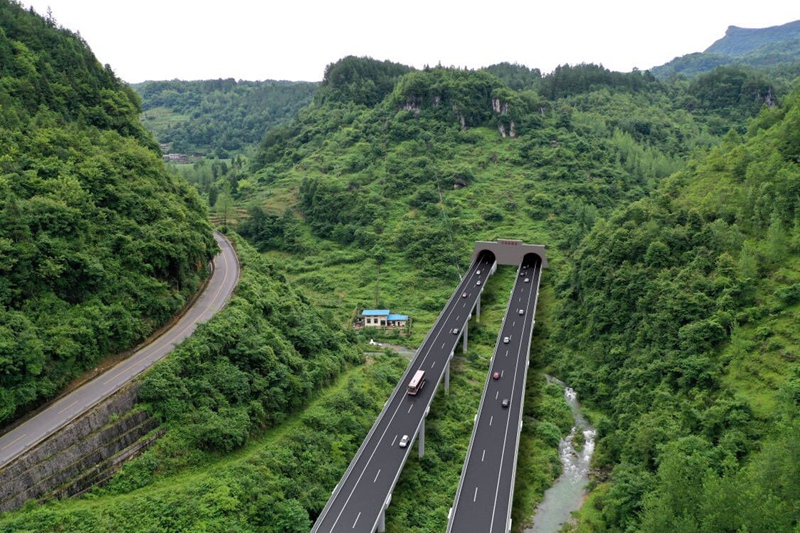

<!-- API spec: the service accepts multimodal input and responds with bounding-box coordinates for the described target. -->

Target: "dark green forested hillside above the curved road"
[0,0,216,424]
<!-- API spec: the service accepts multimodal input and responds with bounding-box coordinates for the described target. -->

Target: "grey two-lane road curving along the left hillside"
[0,232,239,468]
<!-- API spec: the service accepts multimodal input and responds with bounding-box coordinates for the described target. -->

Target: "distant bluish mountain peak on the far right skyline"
[650,20,800,79]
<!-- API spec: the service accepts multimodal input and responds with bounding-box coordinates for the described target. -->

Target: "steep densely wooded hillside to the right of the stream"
[548,92,800,532]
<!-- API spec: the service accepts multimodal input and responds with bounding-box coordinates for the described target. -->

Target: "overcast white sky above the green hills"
[22,0,800,83]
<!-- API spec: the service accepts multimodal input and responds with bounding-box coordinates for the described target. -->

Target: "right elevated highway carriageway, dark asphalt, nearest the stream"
[447,254,541,533]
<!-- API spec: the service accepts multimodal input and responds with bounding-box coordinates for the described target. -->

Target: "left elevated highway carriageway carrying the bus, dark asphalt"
[312,252,494,533]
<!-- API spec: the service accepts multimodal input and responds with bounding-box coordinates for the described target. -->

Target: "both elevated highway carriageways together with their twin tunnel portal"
[311,240,547,533]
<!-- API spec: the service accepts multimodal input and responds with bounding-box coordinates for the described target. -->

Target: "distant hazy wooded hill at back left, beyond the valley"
[131,79,319,158]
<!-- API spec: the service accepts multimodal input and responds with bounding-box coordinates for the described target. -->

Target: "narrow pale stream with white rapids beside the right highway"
[525,376,595,533]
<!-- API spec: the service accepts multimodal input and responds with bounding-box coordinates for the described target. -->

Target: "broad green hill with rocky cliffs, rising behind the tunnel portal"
[247,63,713,278]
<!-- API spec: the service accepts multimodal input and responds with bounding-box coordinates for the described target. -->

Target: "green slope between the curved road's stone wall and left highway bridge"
[0,235,368,533]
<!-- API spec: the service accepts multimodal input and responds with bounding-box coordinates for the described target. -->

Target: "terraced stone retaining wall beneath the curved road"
[0,384,161,511]
